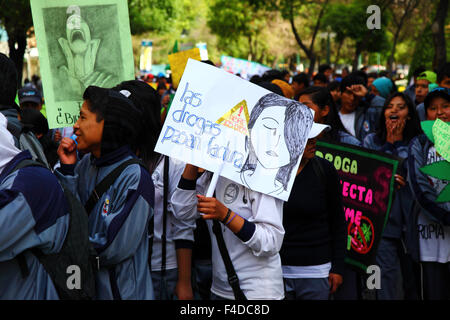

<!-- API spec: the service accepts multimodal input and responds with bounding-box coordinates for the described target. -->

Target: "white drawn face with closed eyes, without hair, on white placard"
[250,106,290,169]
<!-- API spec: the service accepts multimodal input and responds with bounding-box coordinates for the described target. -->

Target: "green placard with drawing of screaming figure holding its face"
[31,0,134,128]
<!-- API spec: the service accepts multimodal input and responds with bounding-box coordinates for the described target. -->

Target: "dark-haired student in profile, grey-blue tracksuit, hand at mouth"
[56,86,154,300]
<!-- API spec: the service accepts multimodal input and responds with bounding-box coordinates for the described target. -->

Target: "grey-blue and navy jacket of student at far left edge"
[0,151,69,300]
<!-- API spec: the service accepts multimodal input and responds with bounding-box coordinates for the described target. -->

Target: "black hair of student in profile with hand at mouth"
[83,85,143,155]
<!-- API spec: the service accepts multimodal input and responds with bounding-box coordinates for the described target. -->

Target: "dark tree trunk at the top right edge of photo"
[431,0,449,70]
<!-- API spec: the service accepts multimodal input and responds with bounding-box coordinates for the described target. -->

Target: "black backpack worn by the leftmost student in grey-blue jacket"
[12,160,99,300]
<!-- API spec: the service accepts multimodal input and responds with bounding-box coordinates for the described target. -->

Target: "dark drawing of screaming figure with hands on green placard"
[42,5,123,101]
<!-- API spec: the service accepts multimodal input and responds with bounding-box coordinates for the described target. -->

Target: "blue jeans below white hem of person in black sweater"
[283,278,330,300]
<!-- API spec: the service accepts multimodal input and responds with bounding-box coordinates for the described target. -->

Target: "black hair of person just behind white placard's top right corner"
[299,86,348,142]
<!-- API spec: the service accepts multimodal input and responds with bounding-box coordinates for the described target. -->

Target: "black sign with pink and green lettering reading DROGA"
[316,141,399,272]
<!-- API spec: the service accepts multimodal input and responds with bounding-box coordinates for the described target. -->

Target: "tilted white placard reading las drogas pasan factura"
[155,59,314,201]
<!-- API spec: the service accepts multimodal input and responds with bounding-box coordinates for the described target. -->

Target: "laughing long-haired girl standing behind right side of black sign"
[363,93,420,300]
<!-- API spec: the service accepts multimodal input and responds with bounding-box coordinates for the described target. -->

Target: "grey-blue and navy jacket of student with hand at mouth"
[56,146,154,300]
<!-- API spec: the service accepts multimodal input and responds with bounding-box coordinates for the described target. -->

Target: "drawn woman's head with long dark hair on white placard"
[241,93,313,194]
